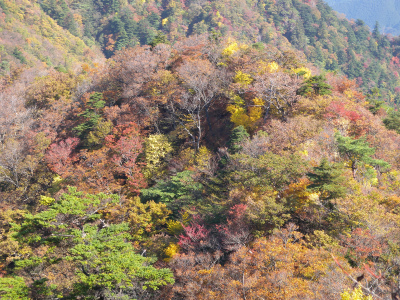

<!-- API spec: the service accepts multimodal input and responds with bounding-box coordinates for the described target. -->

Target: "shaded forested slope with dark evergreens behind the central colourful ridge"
[24,0,400,105]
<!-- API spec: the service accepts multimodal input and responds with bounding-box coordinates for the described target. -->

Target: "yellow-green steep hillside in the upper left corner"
[0,0,102,74]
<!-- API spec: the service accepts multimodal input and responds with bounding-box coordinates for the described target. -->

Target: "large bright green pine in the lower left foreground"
[0,188,174,299]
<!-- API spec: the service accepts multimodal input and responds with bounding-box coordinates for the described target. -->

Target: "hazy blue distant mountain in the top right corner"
[326,0,400,35]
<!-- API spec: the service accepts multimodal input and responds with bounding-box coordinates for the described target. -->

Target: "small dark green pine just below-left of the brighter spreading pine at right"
[307,157,346,200]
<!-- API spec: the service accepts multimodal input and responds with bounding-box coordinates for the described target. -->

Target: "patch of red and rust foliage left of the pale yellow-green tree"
[45,123,146,193]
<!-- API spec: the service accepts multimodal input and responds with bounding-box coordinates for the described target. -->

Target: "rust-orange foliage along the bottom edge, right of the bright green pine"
[169,225,346,299]
